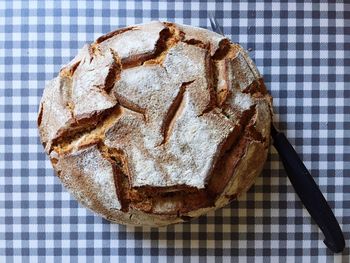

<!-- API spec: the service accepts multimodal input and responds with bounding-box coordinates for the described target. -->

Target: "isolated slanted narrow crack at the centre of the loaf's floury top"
[159,80,195,146]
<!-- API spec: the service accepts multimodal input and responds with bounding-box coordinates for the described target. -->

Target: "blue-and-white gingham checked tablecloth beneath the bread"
[0,0,350,262]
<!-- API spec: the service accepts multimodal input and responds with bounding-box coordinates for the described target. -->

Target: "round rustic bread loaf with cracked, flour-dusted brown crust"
[38,22,272,226]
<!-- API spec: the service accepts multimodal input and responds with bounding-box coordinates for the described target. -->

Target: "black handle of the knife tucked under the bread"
[271,127,345,253]
